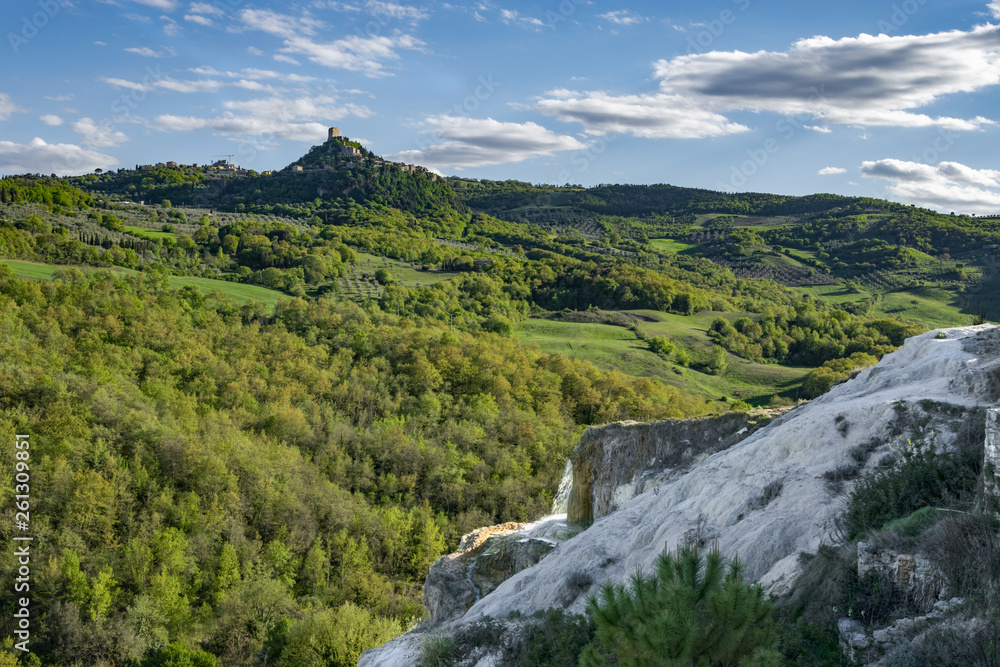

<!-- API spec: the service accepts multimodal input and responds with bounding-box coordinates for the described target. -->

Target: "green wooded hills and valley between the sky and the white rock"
[0,139,1000,666]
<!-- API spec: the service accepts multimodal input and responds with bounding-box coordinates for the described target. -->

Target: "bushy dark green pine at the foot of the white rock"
[580,546,779,667]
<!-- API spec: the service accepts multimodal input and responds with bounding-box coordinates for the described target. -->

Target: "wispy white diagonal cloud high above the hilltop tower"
[240,9,424,77]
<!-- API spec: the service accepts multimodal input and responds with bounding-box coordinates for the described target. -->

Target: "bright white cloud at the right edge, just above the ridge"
[861,159,1000,214]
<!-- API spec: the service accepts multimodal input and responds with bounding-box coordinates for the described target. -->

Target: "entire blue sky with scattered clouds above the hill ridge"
[0,0,1000,214]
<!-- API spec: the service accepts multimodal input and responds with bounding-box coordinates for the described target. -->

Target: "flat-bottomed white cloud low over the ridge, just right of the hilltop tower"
[390,115,587,168]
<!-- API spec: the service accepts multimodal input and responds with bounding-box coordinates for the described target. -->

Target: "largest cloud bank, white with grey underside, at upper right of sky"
[537,23,1000,136]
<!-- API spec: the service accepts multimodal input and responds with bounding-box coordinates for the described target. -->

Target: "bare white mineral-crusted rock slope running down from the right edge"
[359,325,1000,667]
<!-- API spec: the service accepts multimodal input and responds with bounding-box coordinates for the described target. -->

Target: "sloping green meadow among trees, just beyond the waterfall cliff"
[518,310,809,405]
